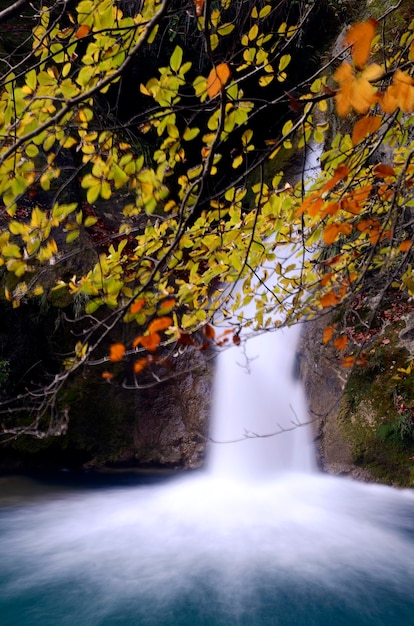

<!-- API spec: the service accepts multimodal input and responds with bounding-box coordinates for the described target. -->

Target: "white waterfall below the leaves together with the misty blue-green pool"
[0,144,414,626]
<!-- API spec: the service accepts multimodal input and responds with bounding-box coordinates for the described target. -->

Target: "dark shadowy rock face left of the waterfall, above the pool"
[0,292,213,471]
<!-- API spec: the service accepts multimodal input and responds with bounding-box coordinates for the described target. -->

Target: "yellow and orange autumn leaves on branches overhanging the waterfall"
[0,0,414,434]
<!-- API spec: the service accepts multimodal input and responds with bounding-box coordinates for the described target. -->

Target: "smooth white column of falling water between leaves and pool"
[209,326,315,480]
